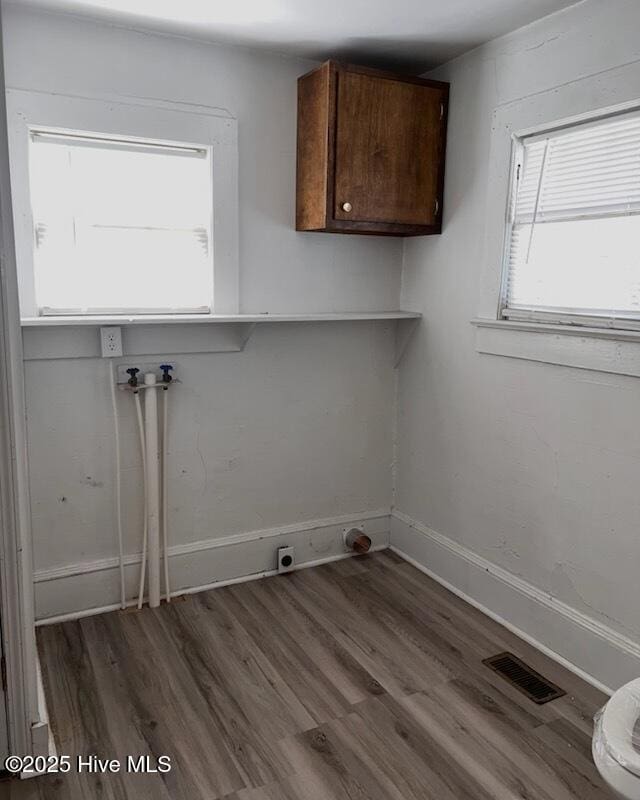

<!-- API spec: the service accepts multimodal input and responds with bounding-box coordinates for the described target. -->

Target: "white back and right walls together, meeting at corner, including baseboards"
[11,0,640,685]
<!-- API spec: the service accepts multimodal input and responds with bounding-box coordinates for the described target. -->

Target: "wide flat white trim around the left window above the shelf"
[7,89,239,321]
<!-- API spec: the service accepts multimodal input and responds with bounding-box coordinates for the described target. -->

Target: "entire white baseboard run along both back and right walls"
[34,510,640,694]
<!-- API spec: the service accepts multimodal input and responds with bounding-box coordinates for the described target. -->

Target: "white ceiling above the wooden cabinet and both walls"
[8,0,576,72]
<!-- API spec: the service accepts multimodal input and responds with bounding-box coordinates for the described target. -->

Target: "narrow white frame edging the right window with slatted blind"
[497,108,640,331]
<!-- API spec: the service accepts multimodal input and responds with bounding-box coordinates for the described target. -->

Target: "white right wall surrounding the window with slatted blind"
[395,0,640,684]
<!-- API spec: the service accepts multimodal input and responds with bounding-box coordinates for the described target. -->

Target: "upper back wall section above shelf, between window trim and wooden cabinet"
[4,6,402,312]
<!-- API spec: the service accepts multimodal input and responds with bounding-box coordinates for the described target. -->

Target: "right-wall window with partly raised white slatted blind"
[502,112,640,327]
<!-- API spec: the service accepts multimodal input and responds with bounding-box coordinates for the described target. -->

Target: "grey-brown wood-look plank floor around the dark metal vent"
[6,551,609,800]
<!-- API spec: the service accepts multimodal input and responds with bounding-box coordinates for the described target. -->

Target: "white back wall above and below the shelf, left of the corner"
[4,7,402,616]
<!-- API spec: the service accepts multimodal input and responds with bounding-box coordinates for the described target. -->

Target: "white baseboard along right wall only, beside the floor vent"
[391,511,640,694]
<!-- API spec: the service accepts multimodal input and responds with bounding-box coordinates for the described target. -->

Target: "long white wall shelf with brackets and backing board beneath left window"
[22,311,421,367]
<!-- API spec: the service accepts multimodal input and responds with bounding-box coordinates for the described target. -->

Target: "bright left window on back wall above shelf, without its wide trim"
[29,129,214,315]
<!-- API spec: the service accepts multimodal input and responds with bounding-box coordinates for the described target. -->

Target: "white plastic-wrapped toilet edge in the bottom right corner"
[591,678,640,800]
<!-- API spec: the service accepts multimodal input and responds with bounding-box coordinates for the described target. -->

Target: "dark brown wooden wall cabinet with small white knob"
[296,61,449,236]
